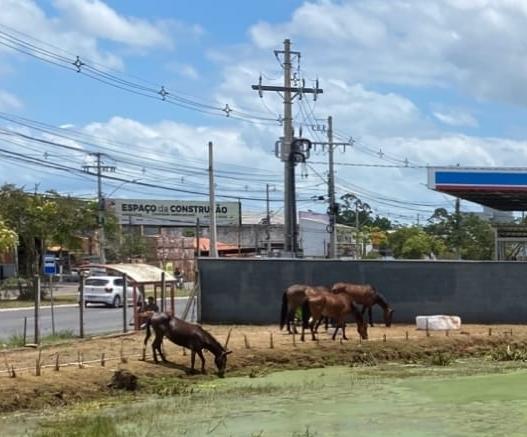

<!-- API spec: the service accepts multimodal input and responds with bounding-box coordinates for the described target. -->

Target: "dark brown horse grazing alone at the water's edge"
[143,313,232,377]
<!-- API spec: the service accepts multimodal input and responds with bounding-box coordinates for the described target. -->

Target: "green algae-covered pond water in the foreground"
[5,363,527,437]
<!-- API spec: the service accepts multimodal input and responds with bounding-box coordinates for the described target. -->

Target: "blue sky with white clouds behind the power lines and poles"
[0,0,527,222]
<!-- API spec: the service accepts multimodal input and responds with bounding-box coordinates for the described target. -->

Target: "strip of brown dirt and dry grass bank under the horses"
[0,325,527,413]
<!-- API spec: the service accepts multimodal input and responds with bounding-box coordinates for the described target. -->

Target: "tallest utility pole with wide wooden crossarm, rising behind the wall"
[252,39,323,256]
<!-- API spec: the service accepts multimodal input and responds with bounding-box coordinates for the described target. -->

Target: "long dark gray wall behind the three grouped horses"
[199,258,527,324]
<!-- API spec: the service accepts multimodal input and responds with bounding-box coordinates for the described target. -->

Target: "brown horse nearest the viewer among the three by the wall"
[301,288,368,341]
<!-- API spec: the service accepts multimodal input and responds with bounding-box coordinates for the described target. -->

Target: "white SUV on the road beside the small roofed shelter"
[79,276,143,308]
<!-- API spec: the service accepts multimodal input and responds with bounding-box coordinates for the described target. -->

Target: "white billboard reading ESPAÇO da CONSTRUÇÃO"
[106,199,241,226]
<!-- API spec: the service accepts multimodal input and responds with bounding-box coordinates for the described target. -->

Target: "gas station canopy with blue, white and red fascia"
[428,167,527,211]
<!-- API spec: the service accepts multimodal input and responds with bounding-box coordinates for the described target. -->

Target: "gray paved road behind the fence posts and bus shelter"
[0,297,196,343]
